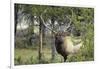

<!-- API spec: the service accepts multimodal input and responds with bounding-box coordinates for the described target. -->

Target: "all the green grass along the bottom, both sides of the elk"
[14,48,94,65]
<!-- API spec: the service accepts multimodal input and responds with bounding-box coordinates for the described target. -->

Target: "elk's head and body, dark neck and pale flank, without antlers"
[55,33,82,62]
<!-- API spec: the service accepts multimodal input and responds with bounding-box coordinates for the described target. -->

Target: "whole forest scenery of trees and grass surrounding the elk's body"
[14,4,94,65]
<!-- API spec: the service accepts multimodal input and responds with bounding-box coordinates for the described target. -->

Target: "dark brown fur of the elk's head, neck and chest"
[55,32,68,62]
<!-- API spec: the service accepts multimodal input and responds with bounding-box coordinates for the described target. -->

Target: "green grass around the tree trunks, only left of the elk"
[14,48,62,65]
